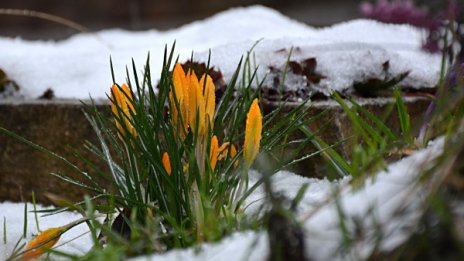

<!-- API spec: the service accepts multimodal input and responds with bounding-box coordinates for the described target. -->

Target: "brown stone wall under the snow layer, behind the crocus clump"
[0,98,429,203]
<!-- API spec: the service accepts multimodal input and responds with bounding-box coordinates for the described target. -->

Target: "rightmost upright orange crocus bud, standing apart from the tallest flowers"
[243,99,263,168]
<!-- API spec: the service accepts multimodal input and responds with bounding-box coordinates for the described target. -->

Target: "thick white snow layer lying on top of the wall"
[0,6,440,99]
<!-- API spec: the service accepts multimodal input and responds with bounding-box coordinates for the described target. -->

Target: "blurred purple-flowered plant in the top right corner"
[359,0,464,142]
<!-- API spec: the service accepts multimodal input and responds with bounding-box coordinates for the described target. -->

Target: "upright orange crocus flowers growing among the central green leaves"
[111,63,262,179]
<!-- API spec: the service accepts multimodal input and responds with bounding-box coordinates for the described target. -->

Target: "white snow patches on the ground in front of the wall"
[0,138,444,260]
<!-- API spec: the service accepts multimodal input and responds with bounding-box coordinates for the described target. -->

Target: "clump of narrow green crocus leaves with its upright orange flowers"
[2,43,320,257]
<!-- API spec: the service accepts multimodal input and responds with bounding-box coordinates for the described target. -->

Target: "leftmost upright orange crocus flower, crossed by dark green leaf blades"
[111,84,137,139]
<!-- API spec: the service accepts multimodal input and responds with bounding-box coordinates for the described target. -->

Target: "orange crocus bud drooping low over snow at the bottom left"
[19,227,66,261]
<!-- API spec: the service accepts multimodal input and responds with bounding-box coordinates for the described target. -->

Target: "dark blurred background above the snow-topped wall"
[0,0,360,39]
